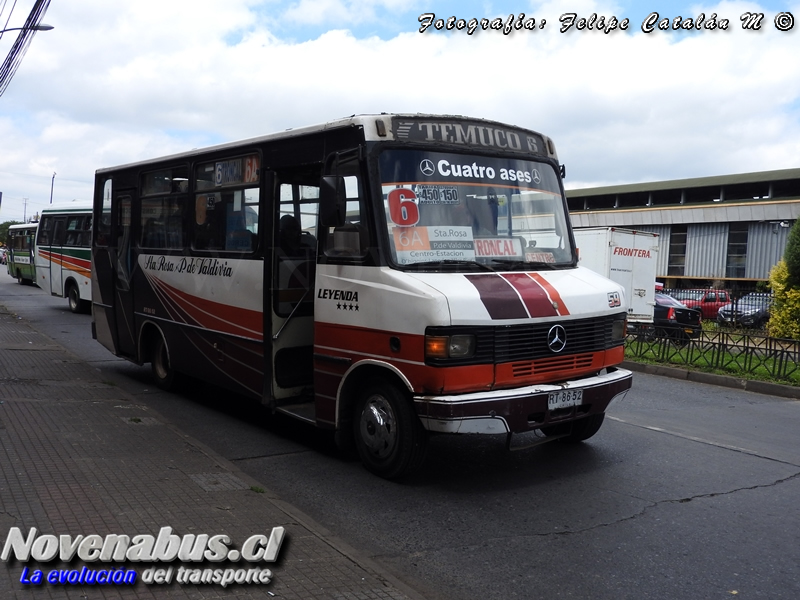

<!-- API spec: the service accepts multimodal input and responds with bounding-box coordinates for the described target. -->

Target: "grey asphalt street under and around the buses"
[0,274,800,600]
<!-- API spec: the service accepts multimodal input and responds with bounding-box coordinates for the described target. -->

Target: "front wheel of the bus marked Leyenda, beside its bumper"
[353,379,428,479]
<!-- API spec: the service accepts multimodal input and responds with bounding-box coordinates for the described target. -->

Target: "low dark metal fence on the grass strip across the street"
[625,331,800,385]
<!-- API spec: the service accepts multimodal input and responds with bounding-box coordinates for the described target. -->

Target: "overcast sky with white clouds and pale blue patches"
[0,0,800,222]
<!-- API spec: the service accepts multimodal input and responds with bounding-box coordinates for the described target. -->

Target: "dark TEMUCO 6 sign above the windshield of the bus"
[393,117,547,155]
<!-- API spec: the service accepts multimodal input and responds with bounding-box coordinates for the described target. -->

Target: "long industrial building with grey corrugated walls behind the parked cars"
[567,169,800,291]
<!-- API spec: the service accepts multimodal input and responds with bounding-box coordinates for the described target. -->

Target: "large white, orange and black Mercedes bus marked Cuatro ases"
[92,114,631,478]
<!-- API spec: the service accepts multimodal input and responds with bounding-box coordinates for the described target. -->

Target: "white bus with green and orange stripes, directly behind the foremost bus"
[36,200,92,313]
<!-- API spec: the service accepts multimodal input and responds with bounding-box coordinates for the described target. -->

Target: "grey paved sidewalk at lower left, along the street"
[0,306,421,600]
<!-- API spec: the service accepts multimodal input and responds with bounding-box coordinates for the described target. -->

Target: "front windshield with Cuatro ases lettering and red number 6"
[379,149,573,268]
